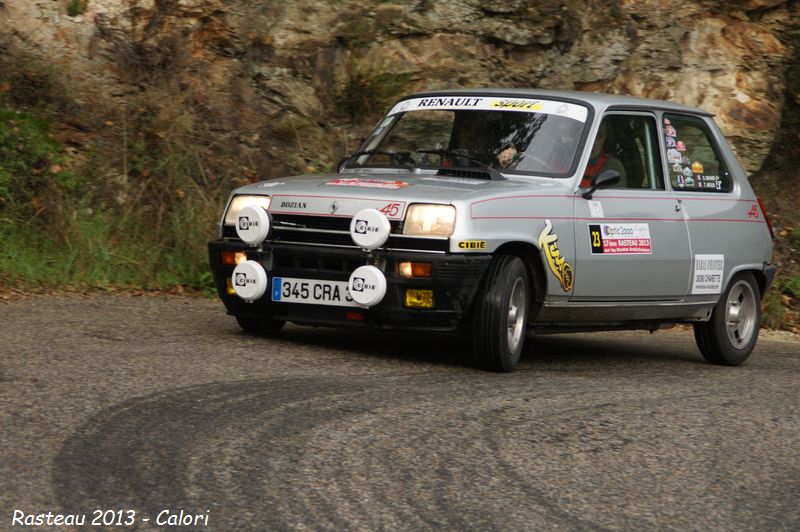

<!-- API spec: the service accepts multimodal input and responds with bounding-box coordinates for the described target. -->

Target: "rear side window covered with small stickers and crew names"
[664,114,733,192]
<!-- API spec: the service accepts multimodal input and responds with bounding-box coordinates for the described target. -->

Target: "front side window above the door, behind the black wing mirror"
[581,114,666,190]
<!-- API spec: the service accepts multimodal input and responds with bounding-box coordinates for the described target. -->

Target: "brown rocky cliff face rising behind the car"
[0,0,800,177]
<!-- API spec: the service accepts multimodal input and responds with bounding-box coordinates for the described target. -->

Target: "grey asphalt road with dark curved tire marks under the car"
[0,296,800,530]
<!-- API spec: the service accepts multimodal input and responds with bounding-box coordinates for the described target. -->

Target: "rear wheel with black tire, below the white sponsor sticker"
[694,272,761,366]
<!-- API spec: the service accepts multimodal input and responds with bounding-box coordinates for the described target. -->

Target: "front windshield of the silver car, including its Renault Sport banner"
[348,97,588,177]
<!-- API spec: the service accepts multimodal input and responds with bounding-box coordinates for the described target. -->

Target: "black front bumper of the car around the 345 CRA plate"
[208,240,491,331]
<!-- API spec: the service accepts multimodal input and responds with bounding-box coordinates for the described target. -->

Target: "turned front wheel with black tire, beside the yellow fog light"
[472,255,530,372]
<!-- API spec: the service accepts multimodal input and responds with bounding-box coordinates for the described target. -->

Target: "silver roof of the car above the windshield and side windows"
[402,87,714,116]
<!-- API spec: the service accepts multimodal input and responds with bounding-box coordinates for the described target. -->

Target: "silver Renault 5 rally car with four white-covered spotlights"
[209,89,775,371]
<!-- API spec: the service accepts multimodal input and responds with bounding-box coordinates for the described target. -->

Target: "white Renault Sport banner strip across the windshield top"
[389,96,588,122]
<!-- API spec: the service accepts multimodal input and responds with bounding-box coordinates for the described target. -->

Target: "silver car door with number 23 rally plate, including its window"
[570,112,691,301]
